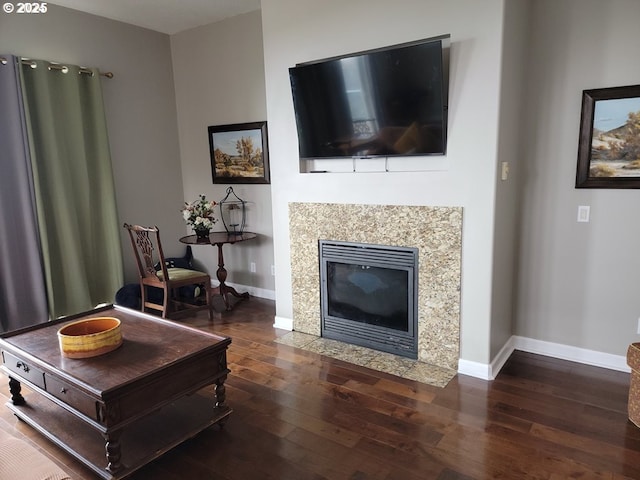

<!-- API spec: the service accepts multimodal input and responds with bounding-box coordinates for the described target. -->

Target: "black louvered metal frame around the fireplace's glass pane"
[318,240,419,359]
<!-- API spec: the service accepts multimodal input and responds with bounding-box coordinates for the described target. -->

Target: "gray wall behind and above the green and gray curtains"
[0,5,184,282]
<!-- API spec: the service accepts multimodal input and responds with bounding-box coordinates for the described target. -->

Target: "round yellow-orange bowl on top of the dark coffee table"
[58,317,122,358]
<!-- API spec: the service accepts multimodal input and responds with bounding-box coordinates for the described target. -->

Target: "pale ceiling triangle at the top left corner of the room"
[50,0,260,35]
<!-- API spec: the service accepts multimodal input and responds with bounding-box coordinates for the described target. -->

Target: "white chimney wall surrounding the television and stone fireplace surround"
[262,0,503,363]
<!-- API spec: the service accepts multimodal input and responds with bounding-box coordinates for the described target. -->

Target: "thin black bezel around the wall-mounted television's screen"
[289,34,451,161]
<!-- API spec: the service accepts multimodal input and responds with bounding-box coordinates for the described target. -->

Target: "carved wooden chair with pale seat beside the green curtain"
[124,223,213,320]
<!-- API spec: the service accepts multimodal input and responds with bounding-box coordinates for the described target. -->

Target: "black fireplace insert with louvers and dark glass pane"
[318,240,418,359]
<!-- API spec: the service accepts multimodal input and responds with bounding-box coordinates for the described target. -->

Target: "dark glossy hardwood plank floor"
[0,298,640,480]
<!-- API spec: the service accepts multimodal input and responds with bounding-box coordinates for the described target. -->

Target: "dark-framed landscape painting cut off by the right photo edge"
[576,85,640,188]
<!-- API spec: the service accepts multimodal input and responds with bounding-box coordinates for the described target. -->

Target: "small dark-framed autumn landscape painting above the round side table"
[208,122,270,183]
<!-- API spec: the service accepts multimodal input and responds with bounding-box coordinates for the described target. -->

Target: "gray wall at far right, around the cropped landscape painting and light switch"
[515,0,640,356]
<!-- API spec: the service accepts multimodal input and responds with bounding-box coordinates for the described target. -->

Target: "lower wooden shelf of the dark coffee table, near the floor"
[7,390,231,480]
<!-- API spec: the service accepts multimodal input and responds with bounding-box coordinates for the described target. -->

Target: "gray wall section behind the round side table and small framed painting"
[171,11,277,298]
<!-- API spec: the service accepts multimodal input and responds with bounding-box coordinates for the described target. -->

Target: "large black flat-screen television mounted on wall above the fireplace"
[289,35,449,159]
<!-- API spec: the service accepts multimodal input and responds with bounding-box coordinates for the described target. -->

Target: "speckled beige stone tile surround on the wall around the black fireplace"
[289,203,462,371]
